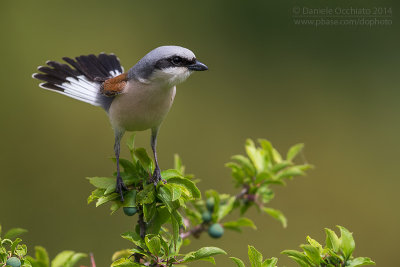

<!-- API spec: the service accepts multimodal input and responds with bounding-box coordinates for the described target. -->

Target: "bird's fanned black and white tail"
[32,53,124,110]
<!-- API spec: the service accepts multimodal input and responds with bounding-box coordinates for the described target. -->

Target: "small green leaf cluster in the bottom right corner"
[282,226,375,267]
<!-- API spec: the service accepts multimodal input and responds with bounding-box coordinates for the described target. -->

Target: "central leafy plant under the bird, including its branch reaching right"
[84,136,311,266]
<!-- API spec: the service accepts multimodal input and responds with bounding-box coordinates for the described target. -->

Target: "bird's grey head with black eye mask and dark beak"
[128,46,208,85]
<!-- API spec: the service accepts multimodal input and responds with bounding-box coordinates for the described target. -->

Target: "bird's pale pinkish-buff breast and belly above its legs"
[109,82,175,131]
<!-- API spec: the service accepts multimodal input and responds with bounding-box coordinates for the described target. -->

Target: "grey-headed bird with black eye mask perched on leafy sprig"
[32,45,208,202]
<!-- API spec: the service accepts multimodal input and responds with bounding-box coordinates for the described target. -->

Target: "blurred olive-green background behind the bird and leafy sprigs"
[0,0,400,266]
